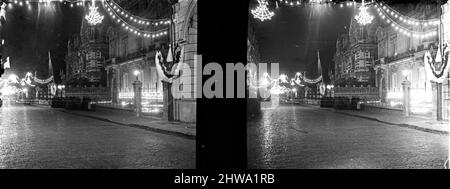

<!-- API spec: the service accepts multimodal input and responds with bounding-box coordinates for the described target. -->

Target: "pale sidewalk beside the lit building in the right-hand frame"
[308,105,450,135]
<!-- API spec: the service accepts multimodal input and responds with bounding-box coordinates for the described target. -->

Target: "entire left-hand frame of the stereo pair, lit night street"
[0,0,197,169]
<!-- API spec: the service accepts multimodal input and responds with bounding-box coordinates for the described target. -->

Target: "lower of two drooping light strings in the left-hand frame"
[104,0,168,38]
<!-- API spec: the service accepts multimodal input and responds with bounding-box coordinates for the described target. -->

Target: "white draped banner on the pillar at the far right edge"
[424,44,450,83]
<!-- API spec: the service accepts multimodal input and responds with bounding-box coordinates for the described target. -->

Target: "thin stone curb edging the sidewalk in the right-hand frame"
[298,105,449,136]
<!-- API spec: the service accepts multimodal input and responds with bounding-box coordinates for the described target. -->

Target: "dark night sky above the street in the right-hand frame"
[251,5,354,78]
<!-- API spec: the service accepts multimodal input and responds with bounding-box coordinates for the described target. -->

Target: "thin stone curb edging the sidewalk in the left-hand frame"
[32,104,196,140]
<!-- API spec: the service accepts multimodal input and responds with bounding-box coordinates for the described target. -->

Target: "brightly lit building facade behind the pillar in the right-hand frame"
[375,5,438,113]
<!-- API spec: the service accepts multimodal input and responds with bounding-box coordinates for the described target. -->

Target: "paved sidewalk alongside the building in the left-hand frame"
[37,105,196,139]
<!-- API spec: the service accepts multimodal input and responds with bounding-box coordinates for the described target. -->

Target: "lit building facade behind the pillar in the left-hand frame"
[106,0,170,113]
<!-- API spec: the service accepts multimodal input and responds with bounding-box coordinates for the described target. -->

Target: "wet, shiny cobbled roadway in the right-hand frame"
[247,105,448,169]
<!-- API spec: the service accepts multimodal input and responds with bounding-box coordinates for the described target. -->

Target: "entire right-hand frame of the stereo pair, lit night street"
[247,0,450,169]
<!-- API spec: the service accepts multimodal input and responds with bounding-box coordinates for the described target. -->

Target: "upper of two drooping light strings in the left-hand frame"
[105,0,171,26]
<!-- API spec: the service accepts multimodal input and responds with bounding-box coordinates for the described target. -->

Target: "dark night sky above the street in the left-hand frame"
[4,3,84,79]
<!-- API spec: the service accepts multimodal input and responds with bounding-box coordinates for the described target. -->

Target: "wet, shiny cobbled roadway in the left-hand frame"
[0,105,195,169]
